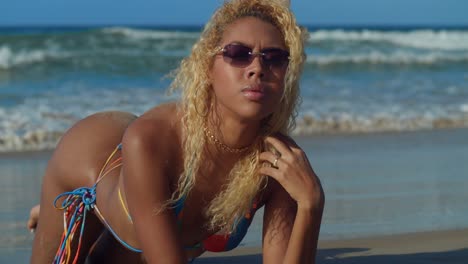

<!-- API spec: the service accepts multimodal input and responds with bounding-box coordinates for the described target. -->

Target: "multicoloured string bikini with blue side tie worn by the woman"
[53,144,258,264]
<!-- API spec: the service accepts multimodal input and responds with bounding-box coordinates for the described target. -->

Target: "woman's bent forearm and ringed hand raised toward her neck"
[260,137,325,264]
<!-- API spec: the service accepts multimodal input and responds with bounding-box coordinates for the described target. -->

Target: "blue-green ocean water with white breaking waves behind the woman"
[0,27,468,152]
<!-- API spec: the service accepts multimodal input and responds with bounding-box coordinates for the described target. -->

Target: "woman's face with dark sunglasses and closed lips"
[211,17,288,122]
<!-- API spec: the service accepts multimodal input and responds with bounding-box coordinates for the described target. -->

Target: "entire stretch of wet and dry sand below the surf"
[0,129,468,264]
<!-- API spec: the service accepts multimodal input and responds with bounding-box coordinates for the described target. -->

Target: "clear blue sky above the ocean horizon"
[0,0,468,26]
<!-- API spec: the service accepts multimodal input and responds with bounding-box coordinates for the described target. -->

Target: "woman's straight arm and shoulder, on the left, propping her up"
[122,116,187,264]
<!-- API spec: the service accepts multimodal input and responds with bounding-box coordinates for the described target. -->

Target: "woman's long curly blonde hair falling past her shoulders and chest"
[168,0,307,232]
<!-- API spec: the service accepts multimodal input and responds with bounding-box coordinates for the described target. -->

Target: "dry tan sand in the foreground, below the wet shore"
[196,229,468,264]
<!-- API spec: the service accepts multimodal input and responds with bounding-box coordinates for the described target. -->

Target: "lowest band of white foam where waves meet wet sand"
[0,125,468,153]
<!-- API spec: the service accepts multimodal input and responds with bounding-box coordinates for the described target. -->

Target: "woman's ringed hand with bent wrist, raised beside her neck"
[260,135,324,210]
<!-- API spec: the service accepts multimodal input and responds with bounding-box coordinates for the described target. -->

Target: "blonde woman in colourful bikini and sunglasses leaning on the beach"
[28,0,324,263]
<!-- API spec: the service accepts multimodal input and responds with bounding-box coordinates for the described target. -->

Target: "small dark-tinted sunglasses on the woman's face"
[220,43,289,68]
